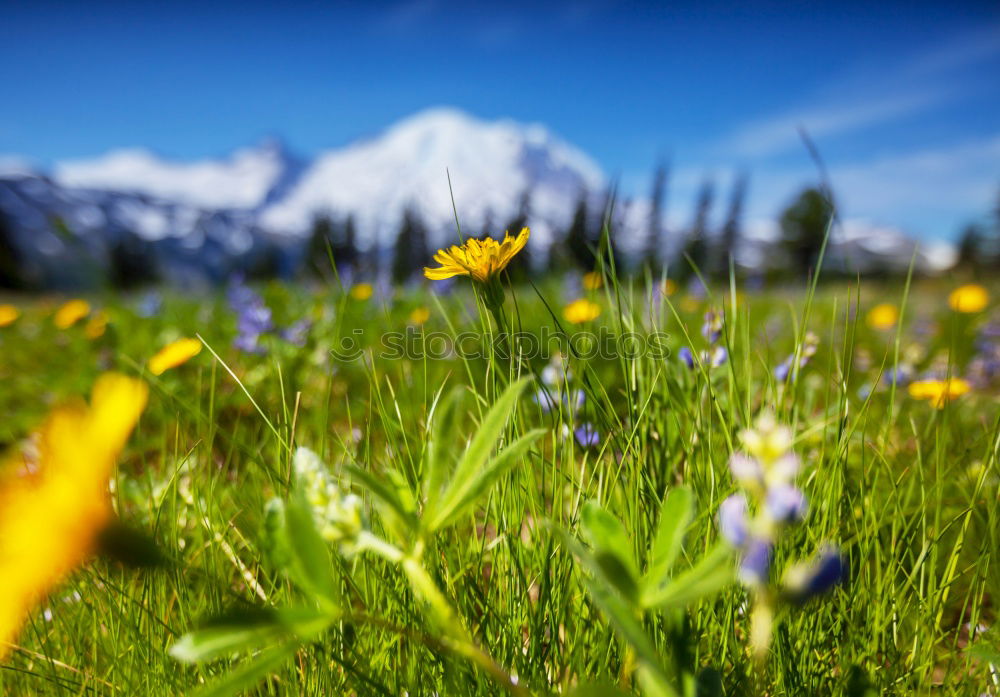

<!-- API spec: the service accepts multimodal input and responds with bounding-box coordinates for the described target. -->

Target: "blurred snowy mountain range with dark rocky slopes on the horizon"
[0,108,952,287]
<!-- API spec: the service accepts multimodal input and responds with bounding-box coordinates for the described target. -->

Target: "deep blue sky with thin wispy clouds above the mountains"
[0,0,1000,237]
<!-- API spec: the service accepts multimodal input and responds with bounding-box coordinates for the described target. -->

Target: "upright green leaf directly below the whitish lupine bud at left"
[264,491,340,611]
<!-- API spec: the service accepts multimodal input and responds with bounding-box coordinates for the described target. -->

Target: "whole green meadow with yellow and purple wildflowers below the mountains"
[0,245,1000,697]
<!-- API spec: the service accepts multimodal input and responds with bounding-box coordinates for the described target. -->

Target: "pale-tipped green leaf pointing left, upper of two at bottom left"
[170,608,334,663]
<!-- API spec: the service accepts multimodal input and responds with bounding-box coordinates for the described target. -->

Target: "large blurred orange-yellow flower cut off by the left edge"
[0,373,148,658]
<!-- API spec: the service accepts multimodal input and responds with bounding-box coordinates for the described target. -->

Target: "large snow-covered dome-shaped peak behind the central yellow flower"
[260,109,605,245]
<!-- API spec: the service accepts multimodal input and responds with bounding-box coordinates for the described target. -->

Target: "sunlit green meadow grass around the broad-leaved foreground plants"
[0,274,1000,696]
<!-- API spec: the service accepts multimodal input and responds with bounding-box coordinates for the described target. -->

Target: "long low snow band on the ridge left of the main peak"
[53,141,294,209]
